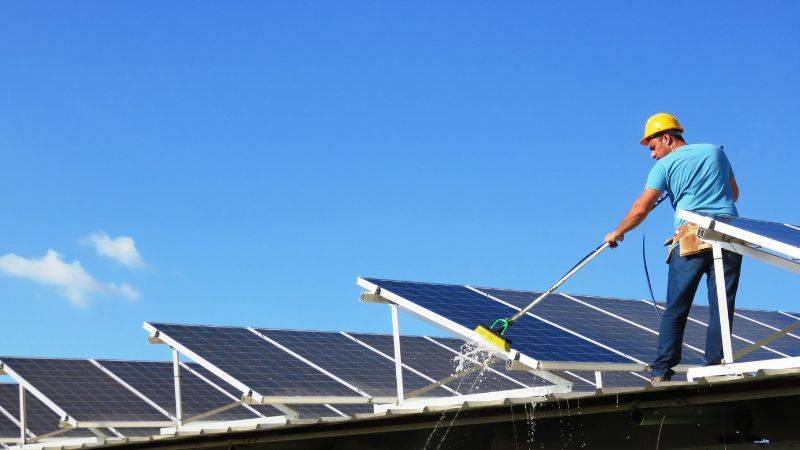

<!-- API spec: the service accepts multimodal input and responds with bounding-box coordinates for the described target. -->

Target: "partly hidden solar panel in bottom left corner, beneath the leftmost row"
[0,383,93,438]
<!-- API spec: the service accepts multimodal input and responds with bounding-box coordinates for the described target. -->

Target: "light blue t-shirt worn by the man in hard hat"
[645,144,739,228]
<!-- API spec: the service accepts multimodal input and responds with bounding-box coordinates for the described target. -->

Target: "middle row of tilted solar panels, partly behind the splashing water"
[151,323,545,404]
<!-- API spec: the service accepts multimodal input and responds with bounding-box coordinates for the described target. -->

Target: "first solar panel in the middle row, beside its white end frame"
[151,323,358,397]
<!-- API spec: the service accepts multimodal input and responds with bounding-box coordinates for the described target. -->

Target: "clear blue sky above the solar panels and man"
[0,1,800,358]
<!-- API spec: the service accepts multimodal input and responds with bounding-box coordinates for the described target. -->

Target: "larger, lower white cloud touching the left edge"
[0,250,139,307]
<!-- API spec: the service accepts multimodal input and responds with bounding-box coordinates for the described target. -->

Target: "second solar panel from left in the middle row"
[257,328,452,397]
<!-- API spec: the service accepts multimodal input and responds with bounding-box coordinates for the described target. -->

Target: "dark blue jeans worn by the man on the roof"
[650,246,742,377]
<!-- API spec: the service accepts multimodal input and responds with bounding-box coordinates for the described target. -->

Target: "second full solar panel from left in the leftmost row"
[98,360,260,420]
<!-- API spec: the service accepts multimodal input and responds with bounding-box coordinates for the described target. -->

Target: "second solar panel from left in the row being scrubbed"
[479,288,703,364]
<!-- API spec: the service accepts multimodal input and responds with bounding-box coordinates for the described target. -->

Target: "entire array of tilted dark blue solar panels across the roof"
[0,213,800,441]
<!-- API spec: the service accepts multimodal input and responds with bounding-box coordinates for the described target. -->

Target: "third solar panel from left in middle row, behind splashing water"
[349,333,545,394]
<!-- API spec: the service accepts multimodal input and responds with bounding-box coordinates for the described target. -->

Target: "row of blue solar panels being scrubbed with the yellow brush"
[365,278,800,385]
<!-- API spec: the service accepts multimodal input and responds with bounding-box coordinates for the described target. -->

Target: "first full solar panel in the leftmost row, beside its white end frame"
[0,357,169,422]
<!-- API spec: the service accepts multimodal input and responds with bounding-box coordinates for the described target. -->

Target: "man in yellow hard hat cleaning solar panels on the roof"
[605,113,742,381]
